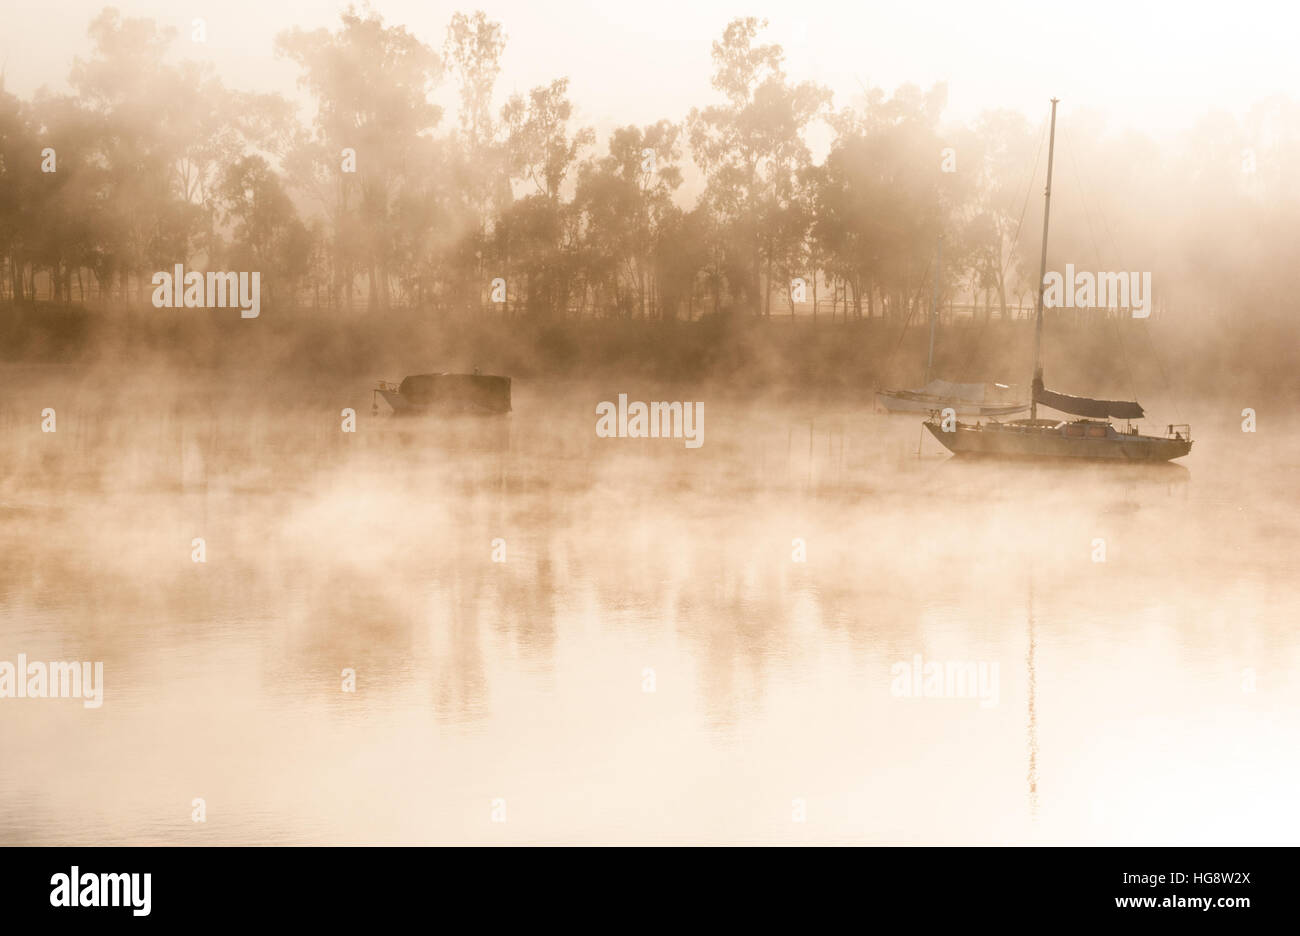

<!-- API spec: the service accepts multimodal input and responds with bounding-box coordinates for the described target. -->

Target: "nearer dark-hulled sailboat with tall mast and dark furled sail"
[923,98,1192,462]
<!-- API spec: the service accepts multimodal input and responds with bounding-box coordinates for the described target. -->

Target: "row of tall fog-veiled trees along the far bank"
[0,8,1300,320]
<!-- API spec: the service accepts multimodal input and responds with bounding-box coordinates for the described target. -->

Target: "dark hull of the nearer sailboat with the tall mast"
[924,420,1192,462]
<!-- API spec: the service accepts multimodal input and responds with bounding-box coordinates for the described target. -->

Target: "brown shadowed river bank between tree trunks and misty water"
[0,303,1279,399]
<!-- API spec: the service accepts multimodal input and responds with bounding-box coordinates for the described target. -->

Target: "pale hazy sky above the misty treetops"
[0,0,1300,133]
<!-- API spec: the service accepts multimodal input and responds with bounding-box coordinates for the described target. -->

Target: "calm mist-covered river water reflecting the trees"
[0,364,1300,844]
